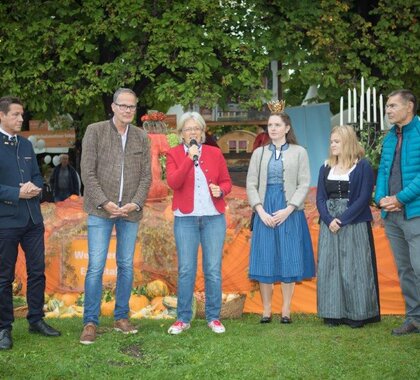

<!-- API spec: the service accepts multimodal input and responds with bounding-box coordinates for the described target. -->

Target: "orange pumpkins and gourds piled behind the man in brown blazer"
[44,280,177,319]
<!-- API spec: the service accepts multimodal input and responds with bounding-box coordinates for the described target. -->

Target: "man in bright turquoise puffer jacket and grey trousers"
[375,90,420,335]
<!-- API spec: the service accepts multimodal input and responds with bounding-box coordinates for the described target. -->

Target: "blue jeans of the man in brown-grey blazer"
[83,215,139,325]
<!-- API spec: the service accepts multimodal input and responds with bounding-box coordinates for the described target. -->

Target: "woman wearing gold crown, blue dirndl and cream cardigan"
[246,101,315,323]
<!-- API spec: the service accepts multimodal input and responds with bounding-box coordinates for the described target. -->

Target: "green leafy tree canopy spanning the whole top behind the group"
[0,0,420,137]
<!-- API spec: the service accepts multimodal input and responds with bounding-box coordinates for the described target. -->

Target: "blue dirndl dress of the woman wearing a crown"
[249,144,315,284]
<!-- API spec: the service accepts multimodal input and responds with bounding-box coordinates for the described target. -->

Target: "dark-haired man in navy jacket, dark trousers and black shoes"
[0,96,60,350]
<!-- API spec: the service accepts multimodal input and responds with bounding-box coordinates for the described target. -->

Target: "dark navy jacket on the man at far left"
[0,132,43,228]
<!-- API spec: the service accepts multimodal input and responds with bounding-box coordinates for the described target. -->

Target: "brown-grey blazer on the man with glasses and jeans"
[81,120,152,222]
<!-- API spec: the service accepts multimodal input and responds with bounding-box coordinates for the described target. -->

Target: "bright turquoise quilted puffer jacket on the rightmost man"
[375,116,420,219]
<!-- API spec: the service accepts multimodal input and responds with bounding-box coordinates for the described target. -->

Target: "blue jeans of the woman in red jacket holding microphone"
[174,214,226,323]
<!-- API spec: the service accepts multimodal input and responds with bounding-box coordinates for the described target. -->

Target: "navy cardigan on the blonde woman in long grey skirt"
[316,159,374,226]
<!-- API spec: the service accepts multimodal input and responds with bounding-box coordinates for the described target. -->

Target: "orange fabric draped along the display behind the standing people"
[16,186,405,314]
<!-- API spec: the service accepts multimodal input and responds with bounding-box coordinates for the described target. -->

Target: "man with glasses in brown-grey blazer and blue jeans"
[80,88,151,344]
